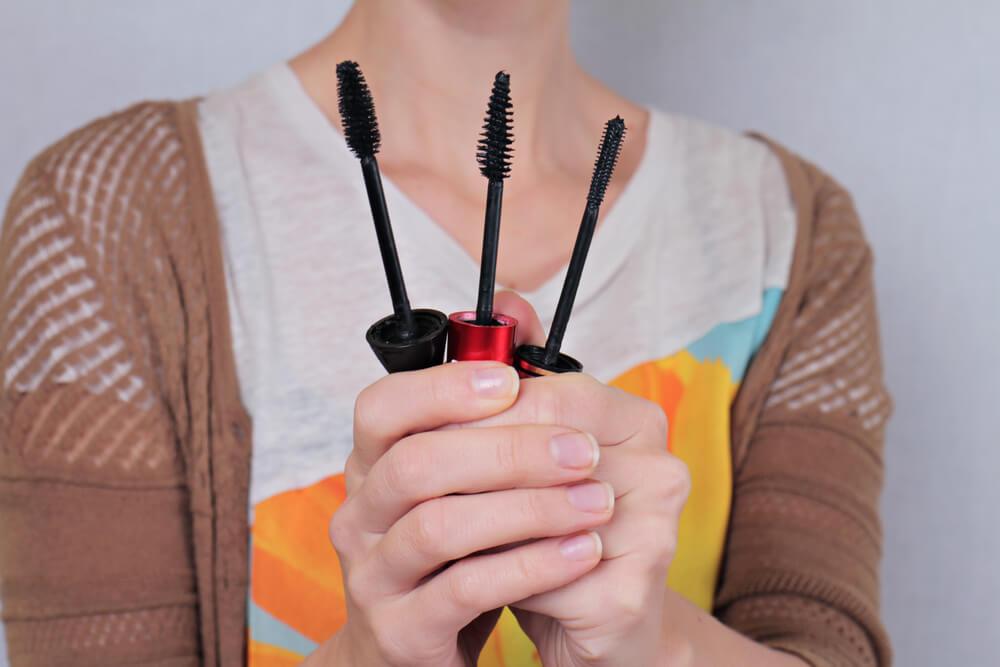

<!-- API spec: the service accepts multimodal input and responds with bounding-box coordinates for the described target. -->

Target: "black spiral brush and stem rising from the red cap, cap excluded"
[476,72,514,326]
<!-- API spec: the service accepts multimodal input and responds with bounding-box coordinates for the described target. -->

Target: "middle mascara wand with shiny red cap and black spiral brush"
[448,72,517,364]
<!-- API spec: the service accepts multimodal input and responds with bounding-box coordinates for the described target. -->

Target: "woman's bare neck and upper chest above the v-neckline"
[292,0,648,290]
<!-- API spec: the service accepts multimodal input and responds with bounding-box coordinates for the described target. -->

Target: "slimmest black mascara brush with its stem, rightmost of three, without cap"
[544,116,625,364]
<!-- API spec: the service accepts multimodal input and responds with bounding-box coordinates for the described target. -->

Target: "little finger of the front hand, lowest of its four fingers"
[410,532,601,632]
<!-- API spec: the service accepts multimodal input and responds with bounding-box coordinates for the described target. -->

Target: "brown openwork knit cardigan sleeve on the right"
[716,163,891,667]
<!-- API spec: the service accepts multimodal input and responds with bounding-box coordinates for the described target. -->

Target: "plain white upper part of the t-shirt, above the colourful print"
[200,64,795,505]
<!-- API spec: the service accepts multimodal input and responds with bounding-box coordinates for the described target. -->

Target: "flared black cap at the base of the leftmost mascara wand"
[365,308,448,373]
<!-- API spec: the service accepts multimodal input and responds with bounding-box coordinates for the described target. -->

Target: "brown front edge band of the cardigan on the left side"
[172,100,251,666]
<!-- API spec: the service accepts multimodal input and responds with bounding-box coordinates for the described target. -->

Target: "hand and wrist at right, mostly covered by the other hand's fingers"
[459,374,690,667]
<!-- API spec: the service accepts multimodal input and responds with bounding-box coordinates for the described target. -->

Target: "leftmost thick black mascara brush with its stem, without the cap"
[337,60,417,340]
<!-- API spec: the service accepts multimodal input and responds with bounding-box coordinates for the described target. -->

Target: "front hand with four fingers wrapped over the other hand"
[328,363,612,667]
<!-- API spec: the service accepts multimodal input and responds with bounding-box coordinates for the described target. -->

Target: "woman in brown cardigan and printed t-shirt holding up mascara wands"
[0,0,890,667]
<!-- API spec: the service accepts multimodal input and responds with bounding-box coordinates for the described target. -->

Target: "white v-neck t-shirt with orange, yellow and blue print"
[199,64,795,665]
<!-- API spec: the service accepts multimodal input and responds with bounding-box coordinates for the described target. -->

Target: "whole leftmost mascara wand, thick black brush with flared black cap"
[337,60,447,373]
